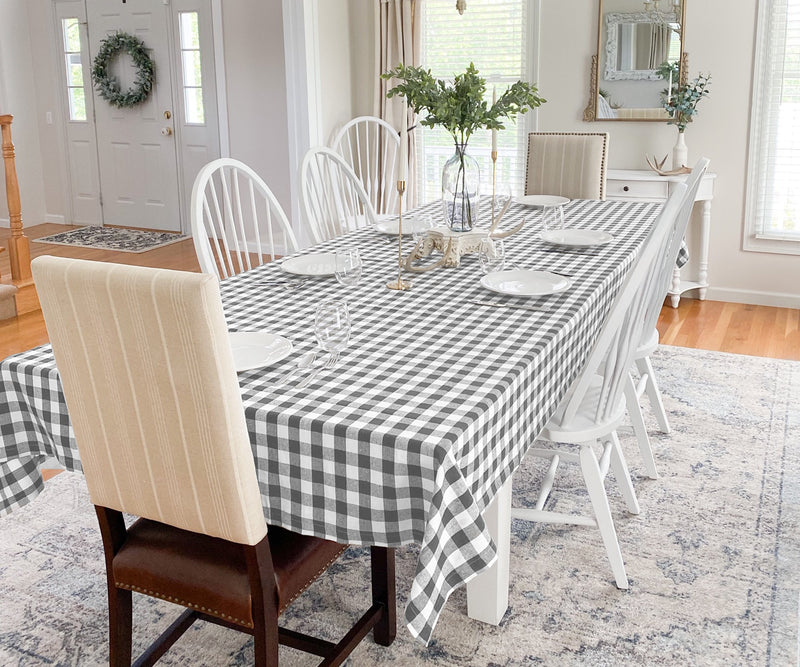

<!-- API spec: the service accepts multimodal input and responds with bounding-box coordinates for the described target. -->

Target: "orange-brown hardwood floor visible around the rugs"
[0,224,800,360]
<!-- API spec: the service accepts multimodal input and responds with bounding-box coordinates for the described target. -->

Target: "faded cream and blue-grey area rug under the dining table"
[0,348,800,667]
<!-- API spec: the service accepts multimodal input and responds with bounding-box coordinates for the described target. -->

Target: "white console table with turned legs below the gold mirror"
[606,169,717,308]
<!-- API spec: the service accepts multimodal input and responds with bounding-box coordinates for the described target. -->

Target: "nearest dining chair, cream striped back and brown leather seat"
[32,257,395,667]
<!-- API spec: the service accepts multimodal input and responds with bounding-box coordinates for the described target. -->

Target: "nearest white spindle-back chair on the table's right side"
[511,184,685,589]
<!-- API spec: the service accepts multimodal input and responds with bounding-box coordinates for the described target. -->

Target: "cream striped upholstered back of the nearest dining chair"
[32,257,267,545]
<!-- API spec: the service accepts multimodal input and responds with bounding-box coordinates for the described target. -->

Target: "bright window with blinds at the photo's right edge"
[744,0,800,254]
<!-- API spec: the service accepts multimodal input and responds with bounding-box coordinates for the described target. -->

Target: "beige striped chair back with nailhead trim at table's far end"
[525,132,608,199]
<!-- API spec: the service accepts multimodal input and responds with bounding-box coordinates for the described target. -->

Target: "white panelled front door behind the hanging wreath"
[86,0,181,232]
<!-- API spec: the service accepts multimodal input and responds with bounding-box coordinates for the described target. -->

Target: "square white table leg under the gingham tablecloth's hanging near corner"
[467,477,511,625]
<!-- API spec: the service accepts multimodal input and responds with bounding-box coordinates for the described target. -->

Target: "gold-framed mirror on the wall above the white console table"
[583,0,689,122]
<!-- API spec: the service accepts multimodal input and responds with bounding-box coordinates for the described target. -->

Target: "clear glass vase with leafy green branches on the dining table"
[381,63,546,231]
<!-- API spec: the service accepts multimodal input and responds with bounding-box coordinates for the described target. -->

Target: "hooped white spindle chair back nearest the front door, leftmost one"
[190,158,297,280]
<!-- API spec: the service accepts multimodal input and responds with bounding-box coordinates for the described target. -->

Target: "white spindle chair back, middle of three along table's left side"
[300,147,376,243]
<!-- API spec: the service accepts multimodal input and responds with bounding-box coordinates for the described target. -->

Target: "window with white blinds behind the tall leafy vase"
[417,0,536,201]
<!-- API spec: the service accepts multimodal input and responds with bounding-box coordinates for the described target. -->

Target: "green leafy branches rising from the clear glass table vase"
[381,63,547,144]
